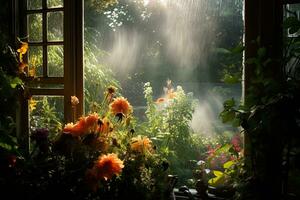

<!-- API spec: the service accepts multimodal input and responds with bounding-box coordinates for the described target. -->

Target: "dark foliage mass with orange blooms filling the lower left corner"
[0,88,169,199]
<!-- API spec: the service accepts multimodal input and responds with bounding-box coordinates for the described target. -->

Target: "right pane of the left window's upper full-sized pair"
[47,12,64,41]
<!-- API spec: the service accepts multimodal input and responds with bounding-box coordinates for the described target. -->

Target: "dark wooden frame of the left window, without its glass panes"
[11,0,84,152]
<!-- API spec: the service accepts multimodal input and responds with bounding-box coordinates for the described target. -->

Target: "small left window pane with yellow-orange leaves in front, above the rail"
[28,46,43,76]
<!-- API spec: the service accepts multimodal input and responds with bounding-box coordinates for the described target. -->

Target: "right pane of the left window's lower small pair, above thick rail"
[47,45,64,77]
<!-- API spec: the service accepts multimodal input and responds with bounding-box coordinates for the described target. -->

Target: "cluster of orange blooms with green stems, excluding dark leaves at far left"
[56,87,166,195]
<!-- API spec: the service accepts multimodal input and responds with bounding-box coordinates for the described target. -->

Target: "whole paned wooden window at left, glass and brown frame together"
[16,0,83,150]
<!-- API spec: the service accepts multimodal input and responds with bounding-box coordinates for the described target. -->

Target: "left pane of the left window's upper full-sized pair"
[27,14,43,42]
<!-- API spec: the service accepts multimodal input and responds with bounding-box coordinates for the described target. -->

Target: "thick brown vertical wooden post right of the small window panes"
[64,0,83,122]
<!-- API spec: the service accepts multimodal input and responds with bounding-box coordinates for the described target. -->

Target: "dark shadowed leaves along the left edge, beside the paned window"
[0,41,23,156]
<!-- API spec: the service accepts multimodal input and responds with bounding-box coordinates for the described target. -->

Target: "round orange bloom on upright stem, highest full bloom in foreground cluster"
[110,97,132,115]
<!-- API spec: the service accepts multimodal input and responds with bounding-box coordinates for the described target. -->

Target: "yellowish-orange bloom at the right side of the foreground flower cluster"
[131,136,153,153]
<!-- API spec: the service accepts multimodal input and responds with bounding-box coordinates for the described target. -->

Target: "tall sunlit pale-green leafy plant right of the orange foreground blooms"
[140,81,206,184]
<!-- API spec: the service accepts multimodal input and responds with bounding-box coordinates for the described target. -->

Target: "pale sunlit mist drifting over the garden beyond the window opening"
[95,0,241,135]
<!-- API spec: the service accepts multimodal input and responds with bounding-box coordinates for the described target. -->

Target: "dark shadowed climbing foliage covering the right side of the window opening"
[219,13,300,199]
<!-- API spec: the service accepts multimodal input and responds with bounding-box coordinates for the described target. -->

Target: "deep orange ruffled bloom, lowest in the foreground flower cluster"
[93,153,124,180]
